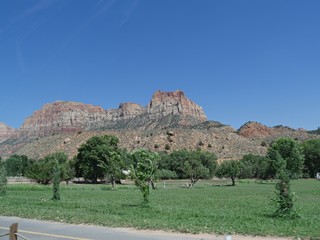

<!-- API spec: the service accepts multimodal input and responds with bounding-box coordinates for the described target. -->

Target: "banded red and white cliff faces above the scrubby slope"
[13,91,207,137]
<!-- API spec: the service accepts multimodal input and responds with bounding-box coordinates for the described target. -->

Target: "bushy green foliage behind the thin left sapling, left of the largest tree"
[26,152,72,184]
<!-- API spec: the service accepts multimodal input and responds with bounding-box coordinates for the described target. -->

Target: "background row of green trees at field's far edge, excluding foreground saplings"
[0,135,320,187]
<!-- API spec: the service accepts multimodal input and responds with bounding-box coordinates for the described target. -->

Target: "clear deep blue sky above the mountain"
[0,0,320,129]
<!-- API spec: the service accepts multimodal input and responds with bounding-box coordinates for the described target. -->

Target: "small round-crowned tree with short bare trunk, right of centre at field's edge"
[216,160,240,186]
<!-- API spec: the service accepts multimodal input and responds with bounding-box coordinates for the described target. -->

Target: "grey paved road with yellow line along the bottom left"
[0,216,225,240]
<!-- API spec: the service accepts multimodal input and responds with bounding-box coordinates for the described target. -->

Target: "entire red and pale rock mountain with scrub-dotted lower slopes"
[0,91,319,160]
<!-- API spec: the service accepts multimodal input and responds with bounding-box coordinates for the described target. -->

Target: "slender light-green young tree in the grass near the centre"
[130,149,159,205]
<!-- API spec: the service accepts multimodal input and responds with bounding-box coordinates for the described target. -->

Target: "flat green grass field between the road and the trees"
[0,180,320,237]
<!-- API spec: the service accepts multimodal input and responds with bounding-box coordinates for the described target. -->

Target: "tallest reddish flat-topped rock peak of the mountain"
[147,90,207,122]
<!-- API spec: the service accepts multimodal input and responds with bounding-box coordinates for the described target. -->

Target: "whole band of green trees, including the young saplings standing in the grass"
[0,135,320,211]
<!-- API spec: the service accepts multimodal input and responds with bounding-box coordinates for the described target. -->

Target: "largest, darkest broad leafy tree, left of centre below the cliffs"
[75,135,119,183]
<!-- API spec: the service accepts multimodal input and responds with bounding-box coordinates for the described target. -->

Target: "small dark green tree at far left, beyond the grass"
[5,154,31,177]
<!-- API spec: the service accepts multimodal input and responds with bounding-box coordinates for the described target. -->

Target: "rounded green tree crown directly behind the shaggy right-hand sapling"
[269,138,304,178]
